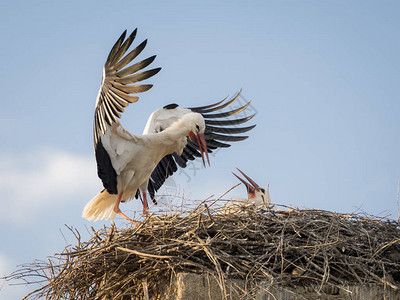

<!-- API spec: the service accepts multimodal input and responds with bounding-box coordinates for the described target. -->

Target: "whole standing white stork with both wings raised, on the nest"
[82,29,255,224]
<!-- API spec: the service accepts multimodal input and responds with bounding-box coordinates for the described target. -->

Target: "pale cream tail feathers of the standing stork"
[82,189,118,221]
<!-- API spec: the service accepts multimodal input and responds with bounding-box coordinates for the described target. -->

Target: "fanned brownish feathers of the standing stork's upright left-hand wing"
[93,29,161,148]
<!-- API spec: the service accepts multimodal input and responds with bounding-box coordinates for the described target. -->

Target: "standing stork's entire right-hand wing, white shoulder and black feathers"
[137,92,256,203]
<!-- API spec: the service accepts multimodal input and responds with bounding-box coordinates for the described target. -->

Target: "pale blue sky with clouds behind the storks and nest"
[0,0,400,299]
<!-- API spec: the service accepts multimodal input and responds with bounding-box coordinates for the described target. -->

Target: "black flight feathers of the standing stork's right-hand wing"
[147,92,256,201]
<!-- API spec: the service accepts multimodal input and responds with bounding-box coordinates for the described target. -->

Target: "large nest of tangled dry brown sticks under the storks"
[8,198,400,299]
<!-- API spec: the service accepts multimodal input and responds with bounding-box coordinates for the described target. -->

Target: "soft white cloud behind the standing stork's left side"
[0,149,101,222]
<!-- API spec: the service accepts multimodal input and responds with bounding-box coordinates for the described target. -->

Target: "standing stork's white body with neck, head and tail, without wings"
[82,113,205,221]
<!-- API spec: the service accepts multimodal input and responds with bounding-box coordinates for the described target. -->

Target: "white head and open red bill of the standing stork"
[182,113,210,166]
